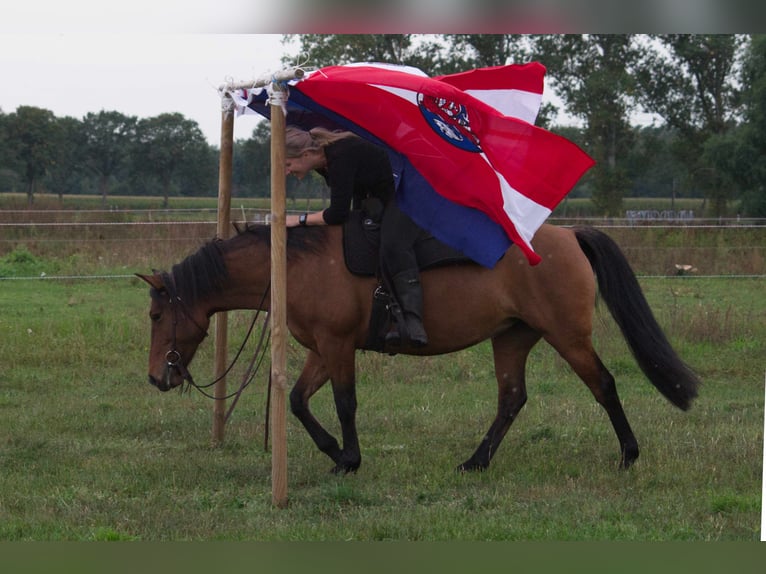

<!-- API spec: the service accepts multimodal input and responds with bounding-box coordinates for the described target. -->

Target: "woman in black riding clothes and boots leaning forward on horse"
[285,126,428,347]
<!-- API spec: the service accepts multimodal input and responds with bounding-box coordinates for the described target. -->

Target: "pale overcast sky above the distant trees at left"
[0,31,288,145]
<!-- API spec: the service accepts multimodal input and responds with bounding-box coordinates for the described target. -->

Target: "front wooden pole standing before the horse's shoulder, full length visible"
[270,82,287,508]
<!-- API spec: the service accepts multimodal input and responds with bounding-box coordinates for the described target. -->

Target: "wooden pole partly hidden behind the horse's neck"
[213,95,234,445]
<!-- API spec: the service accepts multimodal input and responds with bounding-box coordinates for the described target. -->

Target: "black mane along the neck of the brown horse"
[172,224,329,304]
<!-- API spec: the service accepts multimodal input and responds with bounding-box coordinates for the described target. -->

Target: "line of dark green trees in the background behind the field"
[0,34,766,217]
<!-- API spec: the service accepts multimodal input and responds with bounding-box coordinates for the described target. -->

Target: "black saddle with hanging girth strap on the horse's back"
[343,210,473,355]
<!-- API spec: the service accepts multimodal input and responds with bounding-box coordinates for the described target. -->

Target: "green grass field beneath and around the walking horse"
[0,200,766,541]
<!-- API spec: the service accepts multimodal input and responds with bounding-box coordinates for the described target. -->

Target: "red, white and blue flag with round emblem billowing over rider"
[235,63,594,267]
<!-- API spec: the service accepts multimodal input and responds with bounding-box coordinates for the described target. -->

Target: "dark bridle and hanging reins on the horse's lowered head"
[160,272,271,408]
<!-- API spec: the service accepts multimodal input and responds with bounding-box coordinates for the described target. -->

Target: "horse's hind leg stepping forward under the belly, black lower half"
[458,322,540,471]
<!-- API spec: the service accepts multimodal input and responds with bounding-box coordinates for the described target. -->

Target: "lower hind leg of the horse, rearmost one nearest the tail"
[549,337,638,468]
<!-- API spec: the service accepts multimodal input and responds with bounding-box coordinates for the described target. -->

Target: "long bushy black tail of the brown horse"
[574,227,700,410]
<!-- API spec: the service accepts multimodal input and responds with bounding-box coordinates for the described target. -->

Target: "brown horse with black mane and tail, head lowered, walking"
[139,225,699,472]
